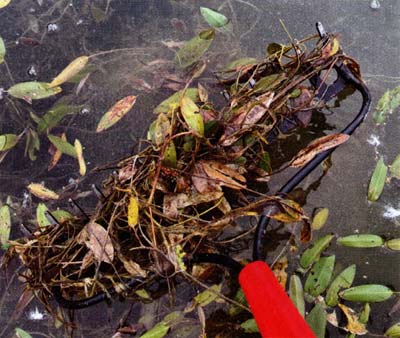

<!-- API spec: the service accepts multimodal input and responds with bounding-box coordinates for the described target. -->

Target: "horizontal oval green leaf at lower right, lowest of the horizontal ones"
[339,284,393,303]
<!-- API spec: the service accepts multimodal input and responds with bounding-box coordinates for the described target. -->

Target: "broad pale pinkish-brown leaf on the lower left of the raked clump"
[80,222,114,264]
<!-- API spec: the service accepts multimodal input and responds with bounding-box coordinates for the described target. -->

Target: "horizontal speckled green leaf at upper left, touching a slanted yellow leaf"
[7,81,61,100]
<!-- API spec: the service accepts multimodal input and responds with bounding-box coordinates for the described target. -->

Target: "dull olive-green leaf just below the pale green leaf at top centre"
[175,29,215,68]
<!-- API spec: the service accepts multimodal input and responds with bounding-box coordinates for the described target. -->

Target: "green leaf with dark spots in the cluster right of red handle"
[304,255,335,297]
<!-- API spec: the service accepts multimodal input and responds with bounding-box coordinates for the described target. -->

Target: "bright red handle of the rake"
[239,261,315,338]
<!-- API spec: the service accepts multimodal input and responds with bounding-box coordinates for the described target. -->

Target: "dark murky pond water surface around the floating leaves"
[0,0,400,337]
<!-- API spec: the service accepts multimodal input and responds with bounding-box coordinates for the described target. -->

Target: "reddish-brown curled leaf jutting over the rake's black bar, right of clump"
[290,134,350,168]
